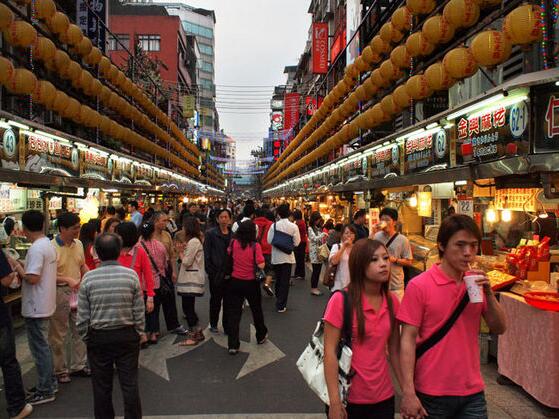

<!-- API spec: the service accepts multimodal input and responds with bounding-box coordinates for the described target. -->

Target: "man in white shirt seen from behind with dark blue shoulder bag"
[268,204,301,313]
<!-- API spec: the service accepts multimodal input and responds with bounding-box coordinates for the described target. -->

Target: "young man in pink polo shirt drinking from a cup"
[397,215,506,419]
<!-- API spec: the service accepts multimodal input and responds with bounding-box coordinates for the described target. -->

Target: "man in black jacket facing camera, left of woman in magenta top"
[204,208,231,333]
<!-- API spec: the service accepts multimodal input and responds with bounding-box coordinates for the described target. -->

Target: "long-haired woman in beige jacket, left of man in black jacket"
[177,216,206,346]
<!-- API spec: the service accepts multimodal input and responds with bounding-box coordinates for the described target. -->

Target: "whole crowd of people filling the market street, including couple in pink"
[0,200,505,419]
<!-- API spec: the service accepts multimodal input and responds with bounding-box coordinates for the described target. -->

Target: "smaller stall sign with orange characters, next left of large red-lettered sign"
[405,129,449,173]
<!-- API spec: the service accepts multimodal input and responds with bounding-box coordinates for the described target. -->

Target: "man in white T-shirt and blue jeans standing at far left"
[11,210,57,405]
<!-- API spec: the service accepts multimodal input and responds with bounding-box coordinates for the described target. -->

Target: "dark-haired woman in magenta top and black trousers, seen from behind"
[223,220,268,355]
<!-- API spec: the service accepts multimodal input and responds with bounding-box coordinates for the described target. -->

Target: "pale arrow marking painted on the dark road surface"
[140,324,285,381]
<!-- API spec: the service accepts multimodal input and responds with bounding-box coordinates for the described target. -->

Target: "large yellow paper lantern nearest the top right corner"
[503,4,542,45]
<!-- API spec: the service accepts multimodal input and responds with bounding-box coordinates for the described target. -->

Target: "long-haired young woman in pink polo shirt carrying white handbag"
[324,239,401,419]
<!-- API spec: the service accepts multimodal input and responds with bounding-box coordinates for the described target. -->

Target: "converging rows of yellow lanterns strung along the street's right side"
[265,0,542,186]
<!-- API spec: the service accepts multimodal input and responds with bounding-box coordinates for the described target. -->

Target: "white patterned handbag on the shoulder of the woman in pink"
[297,291,354,405]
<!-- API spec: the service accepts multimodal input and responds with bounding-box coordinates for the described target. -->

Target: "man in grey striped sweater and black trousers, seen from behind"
[77,233,145,419]
